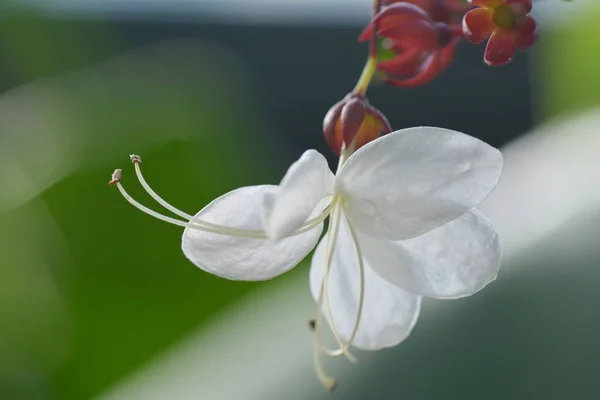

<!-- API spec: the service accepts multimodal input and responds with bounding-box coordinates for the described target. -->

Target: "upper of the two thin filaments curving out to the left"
[130,154,333,238]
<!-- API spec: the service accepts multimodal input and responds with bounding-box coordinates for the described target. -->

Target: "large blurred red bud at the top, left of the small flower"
[359,0,462,87]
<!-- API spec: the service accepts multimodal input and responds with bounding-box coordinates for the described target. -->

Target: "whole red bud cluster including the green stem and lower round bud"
[323,0,548,155]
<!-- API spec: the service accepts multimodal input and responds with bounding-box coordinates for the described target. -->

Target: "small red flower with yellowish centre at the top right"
[463,0,537,65]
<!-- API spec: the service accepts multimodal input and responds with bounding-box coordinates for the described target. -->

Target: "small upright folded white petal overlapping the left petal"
[263,150,334,240]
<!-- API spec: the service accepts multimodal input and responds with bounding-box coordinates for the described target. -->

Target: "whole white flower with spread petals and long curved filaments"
[114,127,502,387]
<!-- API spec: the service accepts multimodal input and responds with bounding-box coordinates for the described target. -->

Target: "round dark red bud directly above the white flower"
[323,94,392,156]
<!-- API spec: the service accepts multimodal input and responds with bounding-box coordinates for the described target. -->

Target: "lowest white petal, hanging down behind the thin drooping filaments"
[310,212,421,350]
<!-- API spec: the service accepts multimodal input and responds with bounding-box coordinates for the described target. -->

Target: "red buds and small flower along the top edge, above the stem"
[359,0,537,87]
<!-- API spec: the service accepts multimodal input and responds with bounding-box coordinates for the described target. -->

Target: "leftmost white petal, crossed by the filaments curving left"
[182,185,323,281]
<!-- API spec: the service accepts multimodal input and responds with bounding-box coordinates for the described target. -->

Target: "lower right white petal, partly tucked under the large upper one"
[360,209,501,299]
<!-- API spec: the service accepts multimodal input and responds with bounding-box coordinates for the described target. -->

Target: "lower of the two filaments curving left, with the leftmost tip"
[113,180,331,239]
